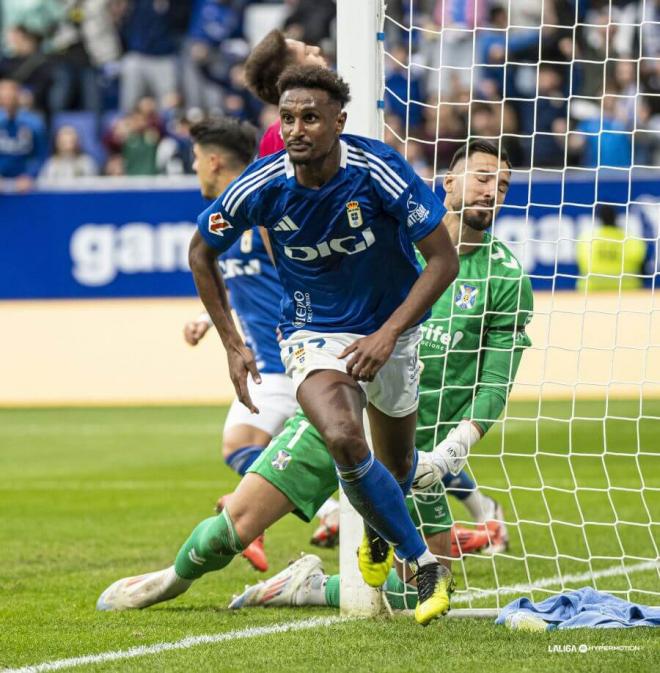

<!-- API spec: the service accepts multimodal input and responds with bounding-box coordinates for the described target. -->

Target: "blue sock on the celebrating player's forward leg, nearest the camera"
[337,454,426,561]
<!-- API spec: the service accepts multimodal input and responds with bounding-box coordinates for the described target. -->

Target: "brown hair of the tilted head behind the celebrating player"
[245,30,295,105]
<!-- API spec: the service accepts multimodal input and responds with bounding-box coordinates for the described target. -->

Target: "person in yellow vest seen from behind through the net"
[577,205,646,292]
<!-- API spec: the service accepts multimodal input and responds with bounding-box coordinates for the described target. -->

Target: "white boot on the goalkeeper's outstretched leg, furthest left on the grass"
[96,566,193,610]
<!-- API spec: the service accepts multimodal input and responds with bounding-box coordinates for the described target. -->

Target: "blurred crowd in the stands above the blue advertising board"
[0,0,660,191]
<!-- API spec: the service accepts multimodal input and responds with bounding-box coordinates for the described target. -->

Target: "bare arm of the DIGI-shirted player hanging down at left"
[188,231,261,414]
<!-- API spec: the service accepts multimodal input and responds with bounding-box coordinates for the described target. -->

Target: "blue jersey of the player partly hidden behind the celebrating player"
[218,227,284,374]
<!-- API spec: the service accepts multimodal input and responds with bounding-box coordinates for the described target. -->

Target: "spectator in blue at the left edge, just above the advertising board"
[0,79,48,192]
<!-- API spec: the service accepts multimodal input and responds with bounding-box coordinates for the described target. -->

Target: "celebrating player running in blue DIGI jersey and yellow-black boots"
[190,66,458,624]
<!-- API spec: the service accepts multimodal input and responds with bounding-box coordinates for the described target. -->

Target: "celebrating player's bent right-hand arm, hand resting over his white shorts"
[339,223,458,381]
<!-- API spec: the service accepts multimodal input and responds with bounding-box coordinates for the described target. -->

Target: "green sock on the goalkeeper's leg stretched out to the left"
[174,509,243,580]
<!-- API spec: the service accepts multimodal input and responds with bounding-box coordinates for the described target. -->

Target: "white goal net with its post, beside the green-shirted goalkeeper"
[337,0,660,611]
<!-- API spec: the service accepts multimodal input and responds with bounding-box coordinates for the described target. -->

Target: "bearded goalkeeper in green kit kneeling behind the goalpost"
[231,142,533,608]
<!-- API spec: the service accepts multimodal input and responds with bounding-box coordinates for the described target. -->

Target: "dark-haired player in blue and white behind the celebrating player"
[184,118,339,572]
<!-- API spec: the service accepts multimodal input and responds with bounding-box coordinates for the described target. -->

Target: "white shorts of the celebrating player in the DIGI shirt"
[280,327,421,417]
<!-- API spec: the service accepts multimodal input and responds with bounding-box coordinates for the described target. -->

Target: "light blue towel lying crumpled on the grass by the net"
[495,587,660,629]
